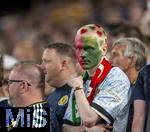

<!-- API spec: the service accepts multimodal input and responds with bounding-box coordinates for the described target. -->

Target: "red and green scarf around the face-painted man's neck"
[72,58,112,125]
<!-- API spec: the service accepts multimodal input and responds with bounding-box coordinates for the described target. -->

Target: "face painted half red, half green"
[76,36,102,70]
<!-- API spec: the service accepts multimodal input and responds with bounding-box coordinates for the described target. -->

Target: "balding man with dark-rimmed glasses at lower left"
[6,62,59,132]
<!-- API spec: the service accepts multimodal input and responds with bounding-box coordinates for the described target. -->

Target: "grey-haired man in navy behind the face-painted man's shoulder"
[110,38,147,132]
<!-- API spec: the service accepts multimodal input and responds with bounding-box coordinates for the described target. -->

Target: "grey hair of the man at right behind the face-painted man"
[112,38,147,71]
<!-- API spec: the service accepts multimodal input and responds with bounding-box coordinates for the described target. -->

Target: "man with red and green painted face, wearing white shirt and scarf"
[63,24,131,132]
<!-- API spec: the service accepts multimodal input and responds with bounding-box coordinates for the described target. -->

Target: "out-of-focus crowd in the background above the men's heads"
[0,0,150,67]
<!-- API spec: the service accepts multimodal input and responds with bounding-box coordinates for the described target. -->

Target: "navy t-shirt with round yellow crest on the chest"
[47,84,72,127]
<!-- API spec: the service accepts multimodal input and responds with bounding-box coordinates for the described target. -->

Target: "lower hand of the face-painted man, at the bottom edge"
[85,124,112,132]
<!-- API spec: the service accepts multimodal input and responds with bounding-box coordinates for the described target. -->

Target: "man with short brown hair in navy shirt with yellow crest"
[41,43,77,127]
